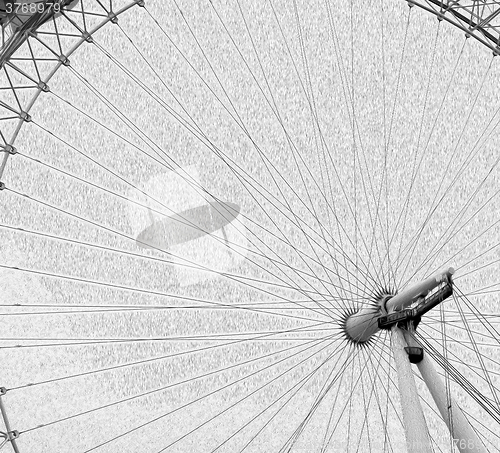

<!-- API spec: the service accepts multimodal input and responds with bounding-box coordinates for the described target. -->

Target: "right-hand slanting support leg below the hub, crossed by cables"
[404,332,487,453]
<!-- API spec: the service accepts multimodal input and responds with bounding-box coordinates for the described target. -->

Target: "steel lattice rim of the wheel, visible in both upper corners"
[0,0,500,154]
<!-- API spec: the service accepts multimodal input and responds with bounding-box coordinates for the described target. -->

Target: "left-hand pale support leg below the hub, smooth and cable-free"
[391,325,432,453]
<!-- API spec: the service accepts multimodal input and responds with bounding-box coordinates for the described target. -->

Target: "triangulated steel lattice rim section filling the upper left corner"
[0,0,140,154]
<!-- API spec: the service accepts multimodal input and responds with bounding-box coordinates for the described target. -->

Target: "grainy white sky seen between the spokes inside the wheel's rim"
[0,0,500,453]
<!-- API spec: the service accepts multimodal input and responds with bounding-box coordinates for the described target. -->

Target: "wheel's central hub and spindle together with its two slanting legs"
[344,267,487,453]
